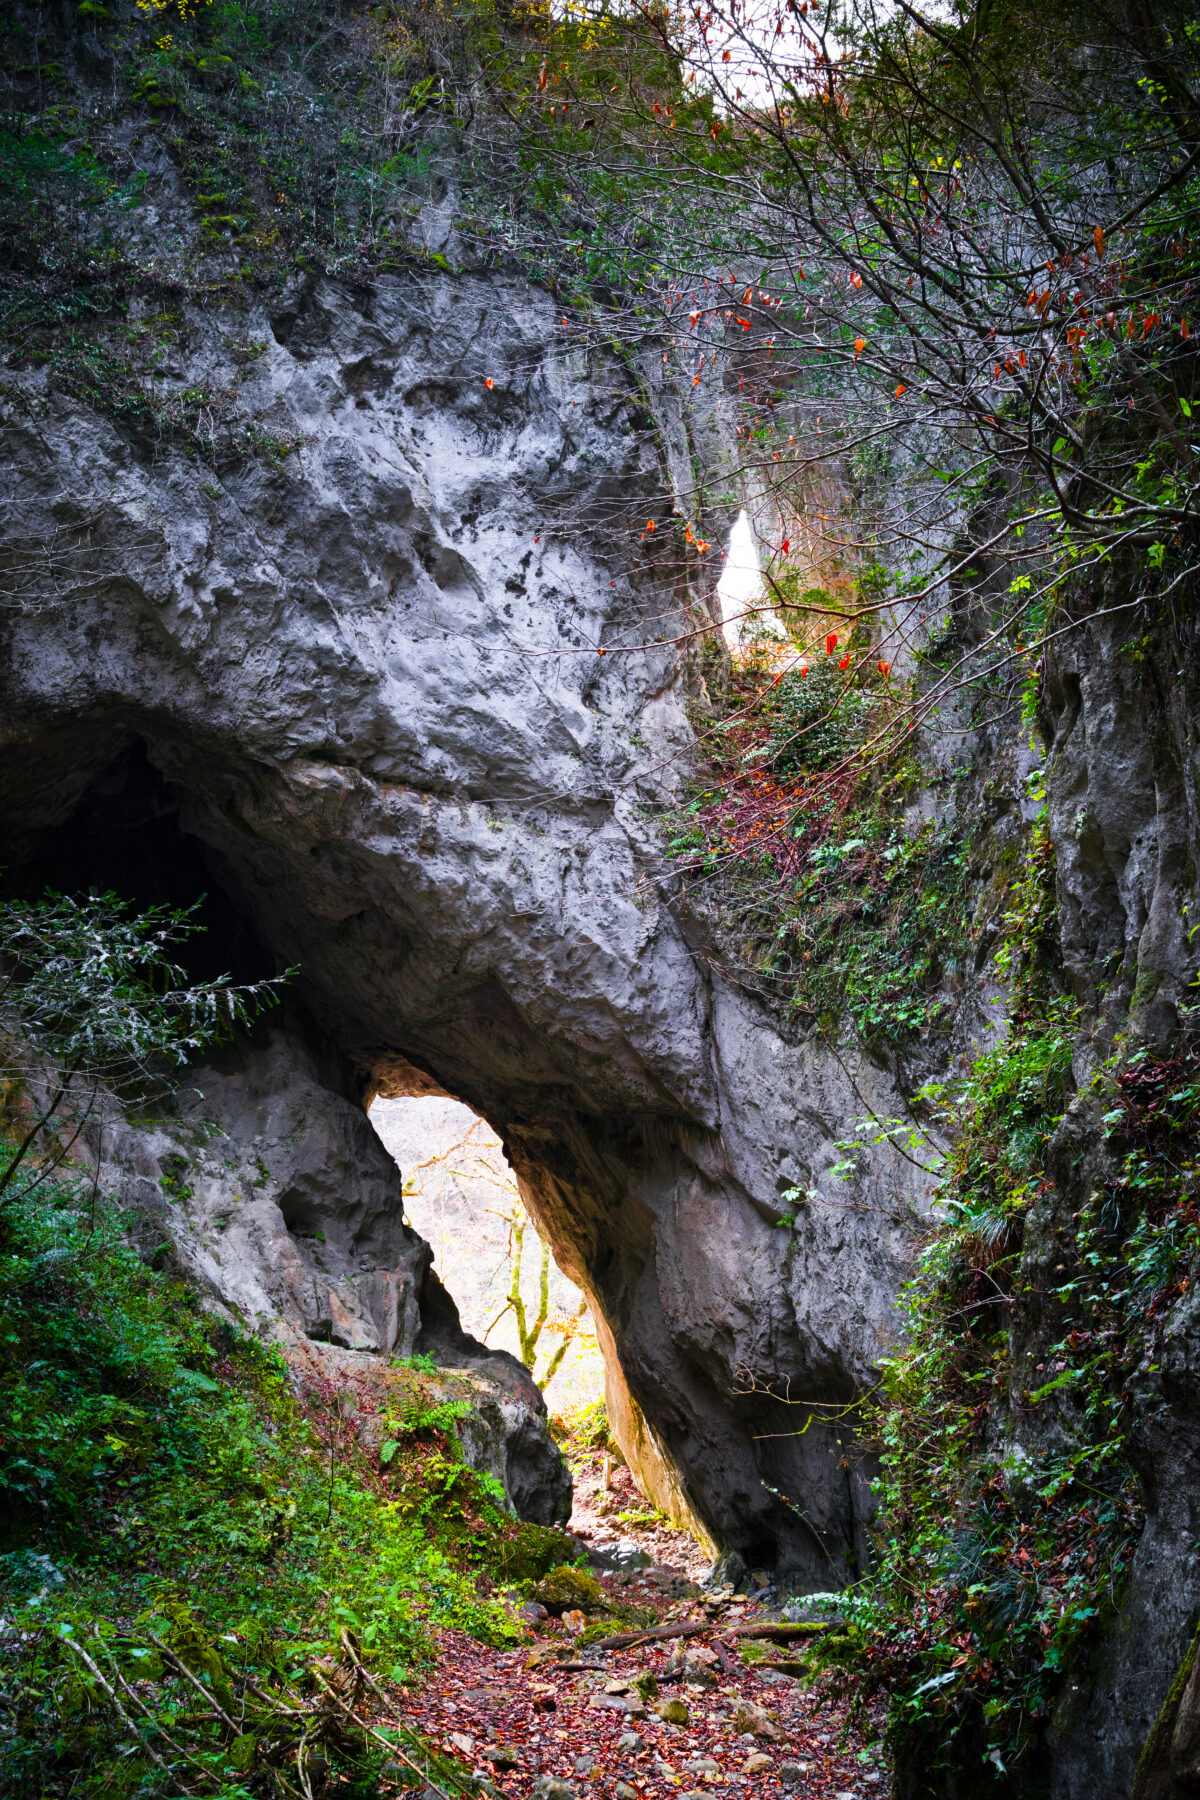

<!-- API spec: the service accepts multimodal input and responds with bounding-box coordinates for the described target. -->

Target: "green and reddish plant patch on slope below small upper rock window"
[666,644,979,1046]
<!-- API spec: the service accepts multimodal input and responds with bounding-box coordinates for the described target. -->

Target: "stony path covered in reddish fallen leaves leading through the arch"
[379,1456,889,1800]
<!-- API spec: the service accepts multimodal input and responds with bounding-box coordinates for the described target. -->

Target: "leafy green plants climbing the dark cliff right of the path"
[788,828,1200,1800]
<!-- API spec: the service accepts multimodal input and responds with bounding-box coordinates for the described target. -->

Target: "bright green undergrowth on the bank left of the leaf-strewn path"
[0,1177,563,1800]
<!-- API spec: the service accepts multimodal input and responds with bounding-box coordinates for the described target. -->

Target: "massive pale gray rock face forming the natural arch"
[0,262,912,1588]
